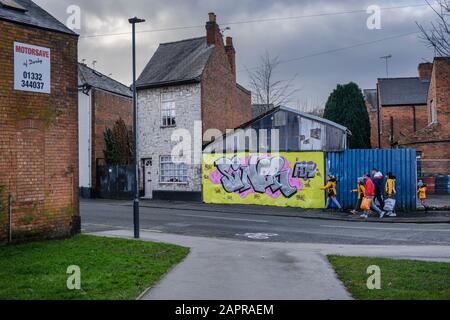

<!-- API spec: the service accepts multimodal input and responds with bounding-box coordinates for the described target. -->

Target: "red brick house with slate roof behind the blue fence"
[364,57,450,181]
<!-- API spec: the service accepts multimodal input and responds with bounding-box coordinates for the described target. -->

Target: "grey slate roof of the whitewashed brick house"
[136,37,214,89]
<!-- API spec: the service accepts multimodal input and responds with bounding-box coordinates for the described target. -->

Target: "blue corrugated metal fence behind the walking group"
[326,149,417,210]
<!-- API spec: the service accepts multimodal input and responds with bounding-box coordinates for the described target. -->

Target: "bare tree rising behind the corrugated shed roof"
[247,52,299,106]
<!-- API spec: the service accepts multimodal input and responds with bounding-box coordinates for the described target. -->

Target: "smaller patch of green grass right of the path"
[328,256,450,300]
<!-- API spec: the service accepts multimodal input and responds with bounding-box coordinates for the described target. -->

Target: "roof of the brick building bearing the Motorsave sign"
[0,0,78,36]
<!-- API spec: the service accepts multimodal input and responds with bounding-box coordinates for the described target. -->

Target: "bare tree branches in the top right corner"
[417,0,450,56]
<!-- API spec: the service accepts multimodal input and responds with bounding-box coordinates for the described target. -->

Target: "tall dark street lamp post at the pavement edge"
[128,17,145,239]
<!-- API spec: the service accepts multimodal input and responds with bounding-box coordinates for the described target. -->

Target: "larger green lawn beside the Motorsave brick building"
[0,235,189,300]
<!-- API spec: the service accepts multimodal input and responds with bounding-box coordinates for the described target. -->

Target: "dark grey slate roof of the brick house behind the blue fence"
[378,78,430,106]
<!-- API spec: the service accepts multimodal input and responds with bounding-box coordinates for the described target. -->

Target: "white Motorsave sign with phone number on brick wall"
[14,42,51,93]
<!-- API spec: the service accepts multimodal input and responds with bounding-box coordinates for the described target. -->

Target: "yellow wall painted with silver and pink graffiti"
[203,152,325,209]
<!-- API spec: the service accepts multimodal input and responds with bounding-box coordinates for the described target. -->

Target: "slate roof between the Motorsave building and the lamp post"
[78,63,133,98]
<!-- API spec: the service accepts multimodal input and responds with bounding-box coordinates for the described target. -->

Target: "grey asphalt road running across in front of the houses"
[81,200,450,245]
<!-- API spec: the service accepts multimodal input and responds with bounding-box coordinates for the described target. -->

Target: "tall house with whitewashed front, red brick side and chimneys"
[137,13,252,200]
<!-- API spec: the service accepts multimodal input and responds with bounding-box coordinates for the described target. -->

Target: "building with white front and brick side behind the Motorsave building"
[78,63,133,198]
